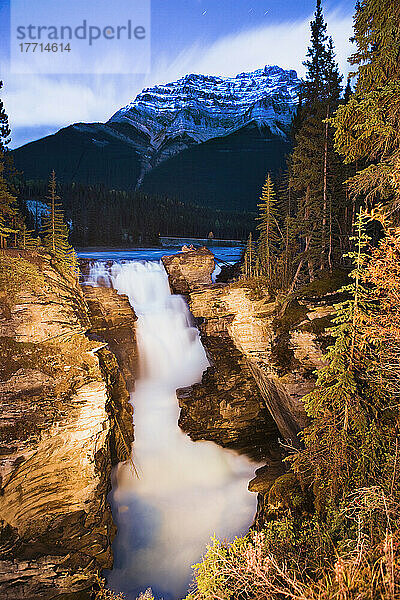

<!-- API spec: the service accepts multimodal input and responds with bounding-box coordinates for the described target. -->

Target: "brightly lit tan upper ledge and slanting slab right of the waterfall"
[190,283,332,445]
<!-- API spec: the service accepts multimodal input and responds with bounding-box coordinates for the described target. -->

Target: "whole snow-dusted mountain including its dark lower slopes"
[13,66,300,209]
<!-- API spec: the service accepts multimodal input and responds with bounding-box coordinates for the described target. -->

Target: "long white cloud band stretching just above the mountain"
[4,11,352,146]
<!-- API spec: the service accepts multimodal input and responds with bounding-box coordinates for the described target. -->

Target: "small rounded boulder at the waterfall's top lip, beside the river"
[162,248,215,295]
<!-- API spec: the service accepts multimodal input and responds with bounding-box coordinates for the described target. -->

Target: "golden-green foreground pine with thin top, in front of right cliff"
[293,211,383,511]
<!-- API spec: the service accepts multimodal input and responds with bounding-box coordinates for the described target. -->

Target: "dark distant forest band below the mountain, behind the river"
[18,181,255,247]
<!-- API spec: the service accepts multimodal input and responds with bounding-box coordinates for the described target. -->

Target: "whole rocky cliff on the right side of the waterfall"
[164,248,333,524]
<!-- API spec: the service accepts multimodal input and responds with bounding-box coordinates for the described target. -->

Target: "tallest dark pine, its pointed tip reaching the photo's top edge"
[289,0,342,280]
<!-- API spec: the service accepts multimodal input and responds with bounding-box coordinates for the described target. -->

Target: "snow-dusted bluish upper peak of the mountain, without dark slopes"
[108,66,300,148]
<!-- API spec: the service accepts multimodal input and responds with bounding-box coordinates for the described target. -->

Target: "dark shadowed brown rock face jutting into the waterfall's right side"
[177,328,280,461]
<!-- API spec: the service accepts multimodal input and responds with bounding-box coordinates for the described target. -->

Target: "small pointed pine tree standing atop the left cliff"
[42,171,77,270]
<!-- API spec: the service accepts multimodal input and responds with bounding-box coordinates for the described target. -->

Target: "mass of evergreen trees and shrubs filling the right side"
[192,0,400,600]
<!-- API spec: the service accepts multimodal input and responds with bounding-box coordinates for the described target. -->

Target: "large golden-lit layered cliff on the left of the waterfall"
[0,253,133,600]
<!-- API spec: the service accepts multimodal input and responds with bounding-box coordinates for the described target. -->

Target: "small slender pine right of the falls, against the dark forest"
[257,174,278,284]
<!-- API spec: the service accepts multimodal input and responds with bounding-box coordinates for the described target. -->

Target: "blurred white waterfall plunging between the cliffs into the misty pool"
[90,262,256,600]
